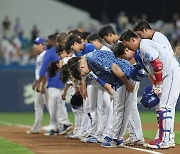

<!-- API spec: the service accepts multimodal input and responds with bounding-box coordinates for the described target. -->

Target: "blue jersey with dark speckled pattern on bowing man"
[86,50,133,89]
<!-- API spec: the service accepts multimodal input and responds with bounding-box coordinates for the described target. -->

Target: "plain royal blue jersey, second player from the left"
[39,46,64,88]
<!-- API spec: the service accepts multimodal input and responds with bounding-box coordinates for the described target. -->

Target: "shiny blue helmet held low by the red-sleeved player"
[140,86,159,109]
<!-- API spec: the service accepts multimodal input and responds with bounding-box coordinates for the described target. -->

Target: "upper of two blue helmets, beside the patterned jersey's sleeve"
[129,65,145,81]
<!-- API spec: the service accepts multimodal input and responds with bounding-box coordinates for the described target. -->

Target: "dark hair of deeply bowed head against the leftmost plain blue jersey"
[60,64,70,83]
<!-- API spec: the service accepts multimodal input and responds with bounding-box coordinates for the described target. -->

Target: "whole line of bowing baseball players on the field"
[26,20,180,149]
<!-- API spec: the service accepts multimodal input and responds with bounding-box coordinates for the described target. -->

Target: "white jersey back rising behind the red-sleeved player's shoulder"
[152,32,174,55]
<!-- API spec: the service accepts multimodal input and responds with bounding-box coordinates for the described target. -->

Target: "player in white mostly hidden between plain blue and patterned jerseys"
[87,33,113,142]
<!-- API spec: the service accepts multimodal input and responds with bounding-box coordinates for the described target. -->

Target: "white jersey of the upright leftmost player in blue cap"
[35,50,46,80]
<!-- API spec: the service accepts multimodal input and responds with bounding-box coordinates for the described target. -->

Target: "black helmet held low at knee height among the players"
[70,92,83,109]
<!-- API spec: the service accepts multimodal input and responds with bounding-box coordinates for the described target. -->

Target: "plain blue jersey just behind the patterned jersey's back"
[76,43,97,57]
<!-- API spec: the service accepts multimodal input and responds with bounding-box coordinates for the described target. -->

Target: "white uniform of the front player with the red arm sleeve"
[140,39,180,144]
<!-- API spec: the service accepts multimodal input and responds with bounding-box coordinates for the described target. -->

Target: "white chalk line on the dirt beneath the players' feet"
[0,121,163,154]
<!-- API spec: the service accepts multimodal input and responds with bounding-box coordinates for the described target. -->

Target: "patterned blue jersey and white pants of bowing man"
[86,50,135,146]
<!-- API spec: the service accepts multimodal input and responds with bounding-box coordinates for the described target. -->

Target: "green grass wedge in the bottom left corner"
[0,137,33,154]
